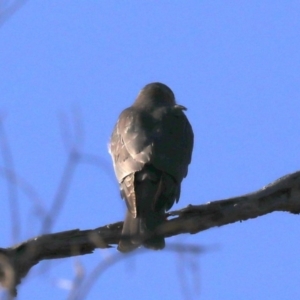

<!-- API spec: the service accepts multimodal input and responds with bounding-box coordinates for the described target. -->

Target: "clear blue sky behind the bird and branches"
[0,0,300,300]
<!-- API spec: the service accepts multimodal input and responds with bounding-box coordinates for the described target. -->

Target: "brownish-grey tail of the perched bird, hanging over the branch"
[118,211,165,252]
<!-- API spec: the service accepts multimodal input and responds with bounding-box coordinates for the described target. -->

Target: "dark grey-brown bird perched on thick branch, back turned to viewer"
[109,82,194,253]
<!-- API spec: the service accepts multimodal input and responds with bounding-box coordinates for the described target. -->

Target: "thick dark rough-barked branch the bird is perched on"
[0,172,300,295]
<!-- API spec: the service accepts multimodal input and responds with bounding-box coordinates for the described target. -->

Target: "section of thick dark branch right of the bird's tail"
[164,171,300,236]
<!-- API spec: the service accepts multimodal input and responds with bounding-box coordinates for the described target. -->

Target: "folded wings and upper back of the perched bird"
[110,106,193,215]
